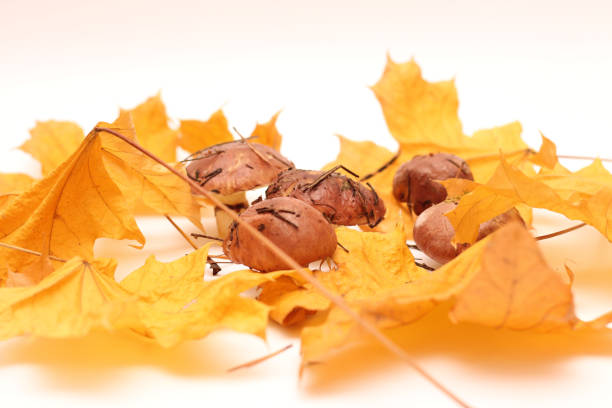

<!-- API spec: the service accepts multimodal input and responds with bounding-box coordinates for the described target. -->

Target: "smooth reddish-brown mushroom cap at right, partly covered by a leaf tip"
[413,201,525,264]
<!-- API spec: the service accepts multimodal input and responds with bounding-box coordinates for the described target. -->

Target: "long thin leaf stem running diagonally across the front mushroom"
[94,127,469,408]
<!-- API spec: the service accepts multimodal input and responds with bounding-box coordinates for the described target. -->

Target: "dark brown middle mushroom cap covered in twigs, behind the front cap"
[266,169,386,227]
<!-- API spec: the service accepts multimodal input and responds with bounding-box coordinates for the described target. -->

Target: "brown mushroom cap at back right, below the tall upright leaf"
[393,153,474,215]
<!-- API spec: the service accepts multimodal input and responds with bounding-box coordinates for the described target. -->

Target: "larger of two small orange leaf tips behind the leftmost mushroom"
[179,109,234,153]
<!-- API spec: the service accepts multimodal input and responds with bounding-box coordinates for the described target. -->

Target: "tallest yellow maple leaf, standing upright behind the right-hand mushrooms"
[326,58,533,236]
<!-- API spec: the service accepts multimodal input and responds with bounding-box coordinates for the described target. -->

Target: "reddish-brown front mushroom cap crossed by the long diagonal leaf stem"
[223,197,337,272]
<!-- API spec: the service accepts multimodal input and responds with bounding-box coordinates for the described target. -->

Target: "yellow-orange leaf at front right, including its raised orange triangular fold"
[302,224,584,364]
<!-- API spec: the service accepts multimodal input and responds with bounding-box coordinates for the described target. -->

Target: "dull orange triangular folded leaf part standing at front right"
[450,224,578,331]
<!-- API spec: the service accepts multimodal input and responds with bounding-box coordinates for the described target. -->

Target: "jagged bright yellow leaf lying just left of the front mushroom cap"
[120,244,273,347]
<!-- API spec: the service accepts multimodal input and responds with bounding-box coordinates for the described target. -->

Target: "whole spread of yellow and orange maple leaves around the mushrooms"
[0,55,612,400]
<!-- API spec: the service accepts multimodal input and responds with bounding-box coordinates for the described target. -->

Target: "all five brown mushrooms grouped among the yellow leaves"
[186,139,520,272]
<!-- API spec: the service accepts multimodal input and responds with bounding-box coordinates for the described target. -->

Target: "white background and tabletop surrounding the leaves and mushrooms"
[0,0,612,407]
